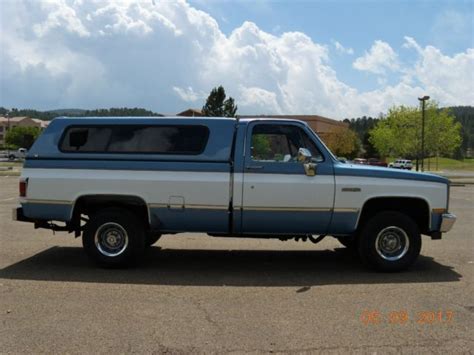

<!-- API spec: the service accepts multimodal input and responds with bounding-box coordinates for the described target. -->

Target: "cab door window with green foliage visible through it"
[250,124,323,163]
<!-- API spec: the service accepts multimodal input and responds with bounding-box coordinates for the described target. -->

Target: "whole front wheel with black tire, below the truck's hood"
[358,211,421,272]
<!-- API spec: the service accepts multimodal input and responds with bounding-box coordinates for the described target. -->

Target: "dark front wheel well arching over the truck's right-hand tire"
[358,197,430,234]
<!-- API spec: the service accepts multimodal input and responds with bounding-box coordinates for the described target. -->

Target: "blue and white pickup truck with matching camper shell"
[13,117,456,271]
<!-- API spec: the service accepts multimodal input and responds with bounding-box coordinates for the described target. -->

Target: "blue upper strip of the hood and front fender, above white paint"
[334,163,449,184]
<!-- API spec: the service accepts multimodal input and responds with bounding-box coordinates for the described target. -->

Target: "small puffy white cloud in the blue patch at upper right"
[353,40,399,74]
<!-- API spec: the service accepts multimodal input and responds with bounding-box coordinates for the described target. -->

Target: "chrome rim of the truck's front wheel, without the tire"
[375,226,410,261]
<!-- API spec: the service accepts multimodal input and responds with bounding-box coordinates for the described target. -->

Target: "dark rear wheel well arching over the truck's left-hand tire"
[72,195,150,225]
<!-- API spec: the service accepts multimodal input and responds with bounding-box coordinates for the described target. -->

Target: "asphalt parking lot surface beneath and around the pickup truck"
[0,176,474,354]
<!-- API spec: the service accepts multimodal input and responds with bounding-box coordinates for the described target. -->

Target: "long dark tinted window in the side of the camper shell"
[59,125,209,155]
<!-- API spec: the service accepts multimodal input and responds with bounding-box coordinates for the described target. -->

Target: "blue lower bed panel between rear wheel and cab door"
[150,208,229,233]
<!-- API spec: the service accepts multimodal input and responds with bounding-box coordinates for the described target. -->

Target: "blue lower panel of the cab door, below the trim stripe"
[242,209,332,235]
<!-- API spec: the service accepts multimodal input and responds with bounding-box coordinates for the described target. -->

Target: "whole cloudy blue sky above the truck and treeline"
[0,0,474,119]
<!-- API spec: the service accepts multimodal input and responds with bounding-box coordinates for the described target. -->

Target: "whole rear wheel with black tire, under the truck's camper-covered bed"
[82,208,146,268]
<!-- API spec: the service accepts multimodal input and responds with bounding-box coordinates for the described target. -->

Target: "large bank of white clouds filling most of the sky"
[0,0,474,118]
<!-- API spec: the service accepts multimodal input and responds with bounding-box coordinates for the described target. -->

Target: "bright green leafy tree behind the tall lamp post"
[369,102,461,158]
